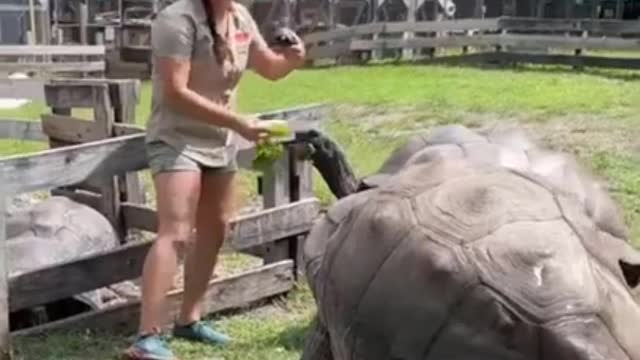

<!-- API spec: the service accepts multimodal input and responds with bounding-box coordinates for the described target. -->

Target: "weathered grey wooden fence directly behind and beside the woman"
[0,80,325,359]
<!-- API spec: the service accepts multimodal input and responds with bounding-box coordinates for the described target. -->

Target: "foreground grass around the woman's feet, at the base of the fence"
[16,285,313,360]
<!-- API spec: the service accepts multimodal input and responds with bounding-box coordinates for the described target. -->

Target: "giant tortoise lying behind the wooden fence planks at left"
[5,196,135,329]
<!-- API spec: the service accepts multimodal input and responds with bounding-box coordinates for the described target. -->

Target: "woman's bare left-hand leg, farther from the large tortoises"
[140,171,201,334]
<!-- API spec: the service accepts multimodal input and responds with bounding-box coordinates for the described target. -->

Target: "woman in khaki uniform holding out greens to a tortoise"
[126,0,305,360]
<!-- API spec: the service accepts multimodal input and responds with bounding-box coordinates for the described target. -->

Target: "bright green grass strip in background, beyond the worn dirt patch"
[0,65,640,124]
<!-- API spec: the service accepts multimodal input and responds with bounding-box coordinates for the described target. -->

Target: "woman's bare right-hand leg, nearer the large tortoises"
[178,173,235,324]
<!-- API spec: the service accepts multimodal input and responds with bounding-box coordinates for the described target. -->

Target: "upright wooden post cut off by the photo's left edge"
[0,195,11,360]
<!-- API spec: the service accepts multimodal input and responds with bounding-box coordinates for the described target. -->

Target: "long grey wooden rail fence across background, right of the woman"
[304,17,640,69]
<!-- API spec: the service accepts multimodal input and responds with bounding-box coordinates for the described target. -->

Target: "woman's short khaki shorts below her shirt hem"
[146,141,238,176]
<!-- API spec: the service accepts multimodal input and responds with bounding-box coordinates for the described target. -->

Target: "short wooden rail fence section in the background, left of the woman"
[0,45,106,77]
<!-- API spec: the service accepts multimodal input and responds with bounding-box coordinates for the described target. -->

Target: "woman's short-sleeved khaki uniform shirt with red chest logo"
[147,0,267,167]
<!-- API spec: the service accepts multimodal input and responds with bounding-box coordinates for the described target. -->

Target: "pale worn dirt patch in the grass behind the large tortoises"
[333,105,640,157]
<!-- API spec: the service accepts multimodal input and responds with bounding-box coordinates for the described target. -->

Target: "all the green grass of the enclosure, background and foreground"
[0,65,640,360]
